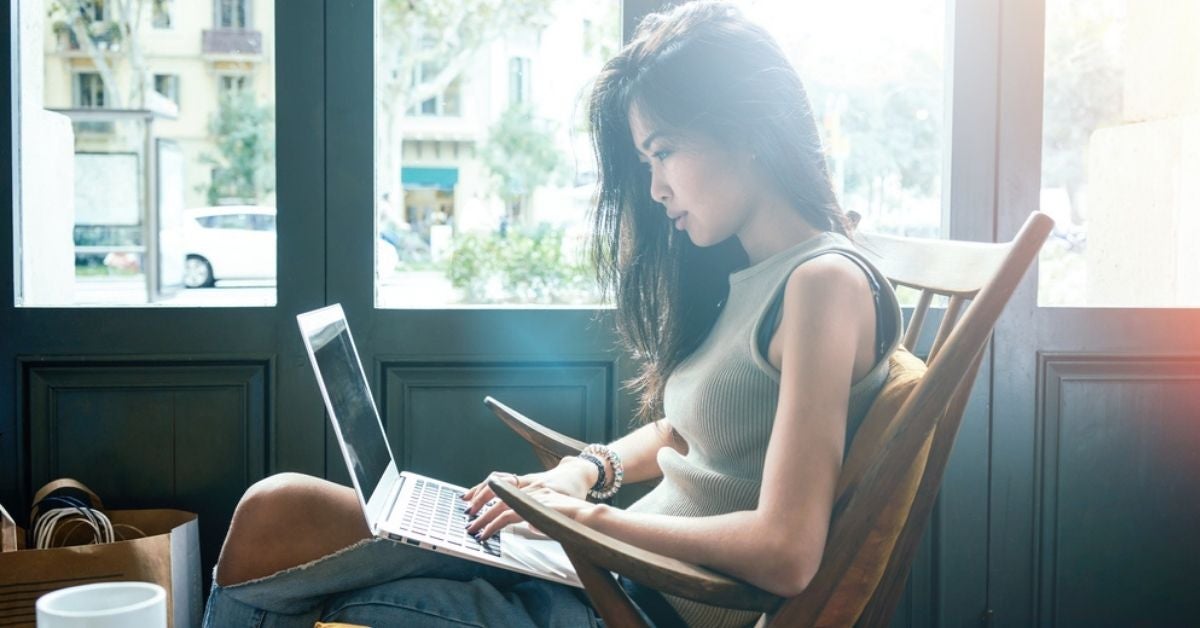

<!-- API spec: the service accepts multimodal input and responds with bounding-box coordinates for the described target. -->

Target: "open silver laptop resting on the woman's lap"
[296,305,582,587]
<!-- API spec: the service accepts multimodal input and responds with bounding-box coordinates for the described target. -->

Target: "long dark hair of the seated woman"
[589,0,850,421]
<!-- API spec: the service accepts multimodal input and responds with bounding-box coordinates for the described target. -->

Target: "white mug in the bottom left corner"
[37,582,167,628]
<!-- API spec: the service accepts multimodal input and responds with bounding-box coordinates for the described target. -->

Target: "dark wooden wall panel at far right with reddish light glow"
[1034,354,1200,626]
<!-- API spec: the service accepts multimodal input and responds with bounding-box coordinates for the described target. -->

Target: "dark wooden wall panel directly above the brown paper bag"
[22,359,271,593]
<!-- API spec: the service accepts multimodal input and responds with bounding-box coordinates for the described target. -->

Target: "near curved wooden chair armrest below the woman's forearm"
[488,482,782,612]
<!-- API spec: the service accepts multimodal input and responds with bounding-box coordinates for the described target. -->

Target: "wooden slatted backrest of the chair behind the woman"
[769,213,1054,626]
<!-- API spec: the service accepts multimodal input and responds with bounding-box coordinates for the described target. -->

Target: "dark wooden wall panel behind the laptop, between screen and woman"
[364,361,614,485]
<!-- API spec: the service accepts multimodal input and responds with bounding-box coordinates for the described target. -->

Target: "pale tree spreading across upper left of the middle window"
[376,0,554,211]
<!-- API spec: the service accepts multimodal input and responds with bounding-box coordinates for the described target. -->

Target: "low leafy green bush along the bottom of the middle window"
[446,225,599,304]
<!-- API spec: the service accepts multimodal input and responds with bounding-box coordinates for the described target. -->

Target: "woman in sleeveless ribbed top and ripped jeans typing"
[206,1,900,626]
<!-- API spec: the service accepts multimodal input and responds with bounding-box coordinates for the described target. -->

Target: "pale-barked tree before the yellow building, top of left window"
[48,0,152,109]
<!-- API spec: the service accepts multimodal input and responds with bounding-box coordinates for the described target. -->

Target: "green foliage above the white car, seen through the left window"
[200,90,275,205]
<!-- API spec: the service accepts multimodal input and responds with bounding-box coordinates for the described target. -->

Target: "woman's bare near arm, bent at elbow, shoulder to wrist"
[481,256,875,597]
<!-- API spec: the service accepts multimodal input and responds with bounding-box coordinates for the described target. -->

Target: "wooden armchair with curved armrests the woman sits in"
[486,213,1052,627]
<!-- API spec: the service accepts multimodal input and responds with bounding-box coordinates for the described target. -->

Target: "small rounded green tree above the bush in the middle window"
[480,103,566,217]
